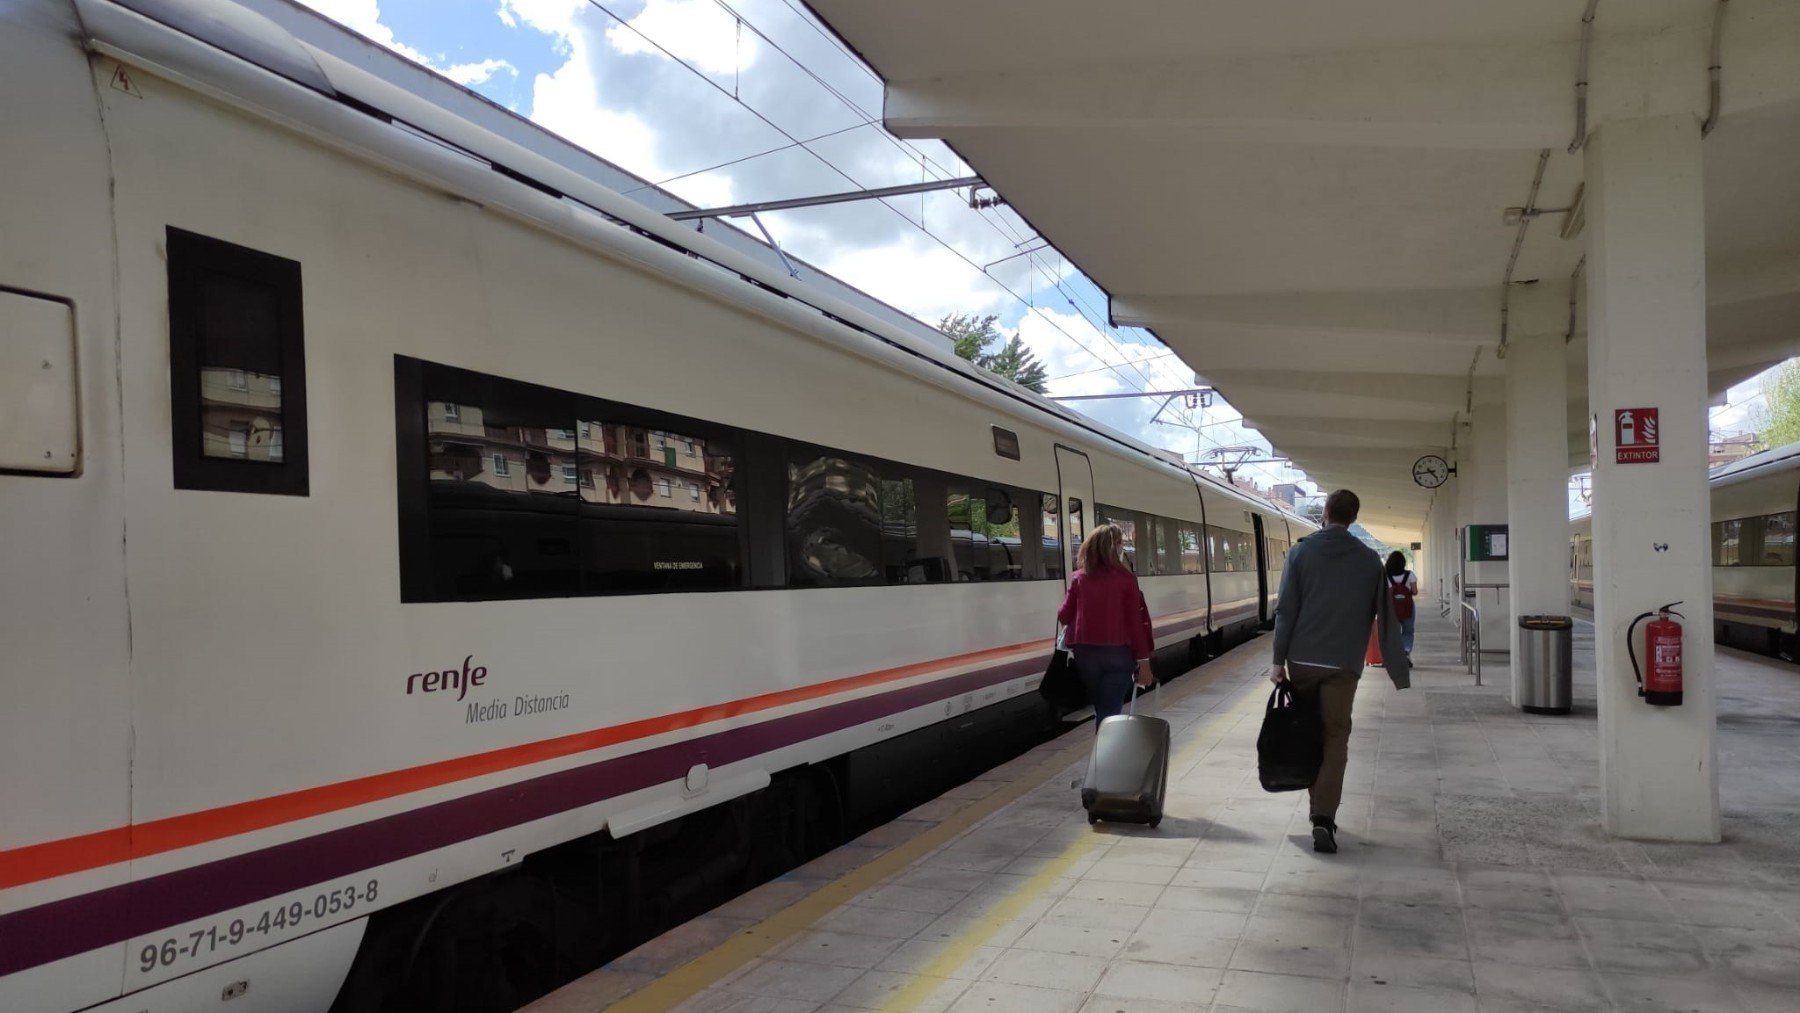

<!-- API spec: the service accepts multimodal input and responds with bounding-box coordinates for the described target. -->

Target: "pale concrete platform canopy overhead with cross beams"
[810,0,1800,542]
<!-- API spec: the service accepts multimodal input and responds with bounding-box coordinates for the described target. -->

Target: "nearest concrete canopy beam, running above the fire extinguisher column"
[884,9,1800,149]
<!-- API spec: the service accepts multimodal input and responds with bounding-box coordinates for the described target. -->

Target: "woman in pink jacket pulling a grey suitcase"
[1057,524,1156,723]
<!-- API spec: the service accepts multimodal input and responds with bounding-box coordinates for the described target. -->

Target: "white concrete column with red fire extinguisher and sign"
[1586,113,1719,842]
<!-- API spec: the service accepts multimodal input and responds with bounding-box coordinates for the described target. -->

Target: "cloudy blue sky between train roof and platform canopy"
[301,0,1298,486]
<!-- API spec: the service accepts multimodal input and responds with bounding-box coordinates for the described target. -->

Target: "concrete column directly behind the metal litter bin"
[1505,286,1570,705]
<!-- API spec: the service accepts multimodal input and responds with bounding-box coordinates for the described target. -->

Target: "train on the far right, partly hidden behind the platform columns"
[1570,443,1800,660]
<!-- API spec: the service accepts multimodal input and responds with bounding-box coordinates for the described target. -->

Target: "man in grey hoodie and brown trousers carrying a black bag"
[1269,489,1413,853]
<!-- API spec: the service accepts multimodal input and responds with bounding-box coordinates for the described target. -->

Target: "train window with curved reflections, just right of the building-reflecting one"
[787,450,886,587]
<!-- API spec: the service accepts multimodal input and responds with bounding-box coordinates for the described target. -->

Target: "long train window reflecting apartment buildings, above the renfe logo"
[396,360,743,601]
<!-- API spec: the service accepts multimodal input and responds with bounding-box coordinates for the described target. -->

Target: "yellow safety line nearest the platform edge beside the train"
[608,658,1267,1013]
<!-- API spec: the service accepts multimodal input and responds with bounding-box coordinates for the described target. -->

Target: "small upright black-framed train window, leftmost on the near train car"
[167,227,308,497]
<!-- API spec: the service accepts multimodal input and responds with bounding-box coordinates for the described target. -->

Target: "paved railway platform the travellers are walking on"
[527,617,1800,1013]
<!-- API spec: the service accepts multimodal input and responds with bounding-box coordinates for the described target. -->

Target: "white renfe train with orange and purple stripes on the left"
[0,0,1312,1013]
